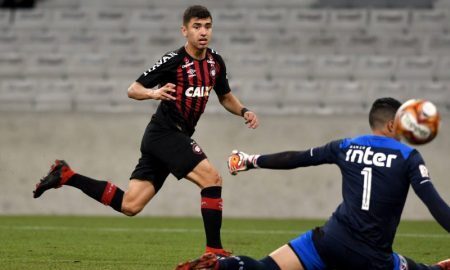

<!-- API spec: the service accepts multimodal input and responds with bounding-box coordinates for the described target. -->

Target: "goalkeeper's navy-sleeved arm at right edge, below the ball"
[408,151,450,232]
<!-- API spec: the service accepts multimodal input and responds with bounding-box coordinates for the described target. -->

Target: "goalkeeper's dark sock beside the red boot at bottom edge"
[218,256,280,270]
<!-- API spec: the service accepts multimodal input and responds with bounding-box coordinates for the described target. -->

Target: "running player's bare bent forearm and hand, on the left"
[128,82,176,100]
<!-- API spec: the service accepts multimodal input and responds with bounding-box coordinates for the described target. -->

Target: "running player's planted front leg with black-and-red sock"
[186,158,229,256]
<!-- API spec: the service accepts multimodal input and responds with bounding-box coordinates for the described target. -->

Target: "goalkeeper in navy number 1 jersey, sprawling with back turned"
[177,98,450,270]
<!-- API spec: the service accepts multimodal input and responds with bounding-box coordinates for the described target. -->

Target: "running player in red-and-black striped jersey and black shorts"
[34,5,258,256]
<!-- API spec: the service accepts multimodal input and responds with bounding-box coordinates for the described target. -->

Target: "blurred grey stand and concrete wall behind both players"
[0,0,450,219]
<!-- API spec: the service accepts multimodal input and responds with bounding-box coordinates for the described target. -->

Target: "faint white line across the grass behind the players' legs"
[0,225,450,238]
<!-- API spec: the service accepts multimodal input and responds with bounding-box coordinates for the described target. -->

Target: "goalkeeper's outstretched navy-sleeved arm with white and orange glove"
[228,141,339,174]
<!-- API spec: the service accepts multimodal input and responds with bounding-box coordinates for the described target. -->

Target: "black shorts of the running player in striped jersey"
[130,121,206,191]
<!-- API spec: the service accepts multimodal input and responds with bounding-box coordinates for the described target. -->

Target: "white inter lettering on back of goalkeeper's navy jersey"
[345,145,397,168]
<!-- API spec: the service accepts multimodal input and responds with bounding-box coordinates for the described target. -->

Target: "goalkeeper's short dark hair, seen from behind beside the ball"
[369,97,402,129]
